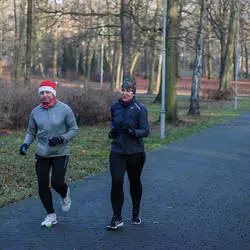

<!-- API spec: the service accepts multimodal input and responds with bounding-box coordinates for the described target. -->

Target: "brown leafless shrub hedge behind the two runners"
[0,84,115,129]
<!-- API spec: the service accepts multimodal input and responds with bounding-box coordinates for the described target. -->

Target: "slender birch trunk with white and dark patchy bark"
[188,0,206,115]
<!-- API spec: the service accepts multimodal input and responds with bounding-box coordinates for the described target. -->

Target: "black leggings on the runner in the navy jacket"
[109,151,145,217]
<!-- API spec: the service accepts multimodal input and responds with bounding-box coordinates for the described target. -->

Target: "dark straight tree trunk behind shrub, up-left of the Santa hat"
[24,0,33,84]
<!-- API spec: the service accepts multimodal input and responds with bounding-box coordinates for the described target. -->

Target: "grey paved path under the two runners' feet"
[0,113,250,250]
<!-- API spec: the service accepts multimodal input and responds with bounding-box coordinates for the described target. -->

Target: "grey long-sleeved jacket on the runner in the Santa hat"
[24,100,78,157]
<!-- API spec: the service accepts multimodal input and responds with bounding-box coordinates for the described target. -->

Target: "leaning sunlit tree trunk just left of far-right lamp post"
[220,0,237,91]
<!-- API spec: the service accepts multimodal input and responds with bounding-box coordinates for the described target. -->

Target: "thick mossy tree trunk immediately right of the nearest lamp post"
[165,0,178,122]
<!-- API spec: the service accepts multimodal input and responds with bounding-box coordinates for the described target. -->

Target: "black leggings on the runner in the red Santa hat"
[36,156,69,214]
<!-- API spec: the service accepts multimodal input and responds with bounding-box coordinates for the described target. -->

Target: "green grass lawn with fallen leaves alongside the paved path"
[0,96,250,207]
